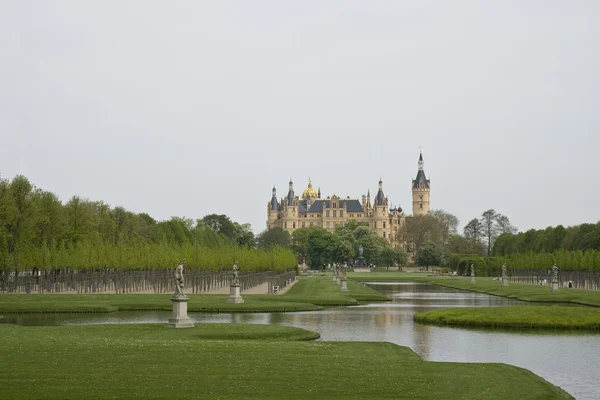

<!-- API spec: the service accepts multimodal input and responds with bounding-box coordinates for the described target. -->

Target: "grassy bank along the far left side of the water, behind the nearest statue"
[0,277,387,313]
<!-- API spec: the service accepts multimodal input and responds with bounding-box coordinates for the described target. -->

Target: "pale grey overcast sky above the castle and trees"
[0,0,600,233]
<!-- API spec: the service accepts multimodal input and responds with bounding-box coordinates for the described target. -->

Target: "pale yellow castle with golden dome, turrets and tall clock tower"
[267,154,430,245]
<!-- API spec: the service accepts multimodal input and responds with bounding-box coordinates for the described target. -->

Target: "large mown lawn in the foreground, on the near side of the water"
[0,324,572,400]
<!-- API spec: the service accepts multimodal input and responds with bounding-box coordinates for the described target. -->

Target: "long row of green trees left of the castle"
[0,175,295,269]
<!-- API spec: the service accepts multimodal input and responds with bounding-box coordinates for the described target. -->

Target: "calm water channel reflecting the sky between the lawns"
[0,282,600,400]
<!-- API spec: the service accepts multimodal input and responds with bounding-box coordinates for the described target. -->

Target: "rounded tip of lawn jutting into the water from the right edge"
[414,306,600,330]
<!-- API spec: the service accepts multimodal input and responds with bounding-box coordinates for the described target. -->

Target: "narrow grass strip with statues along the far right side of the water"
[348,272,600,307]
